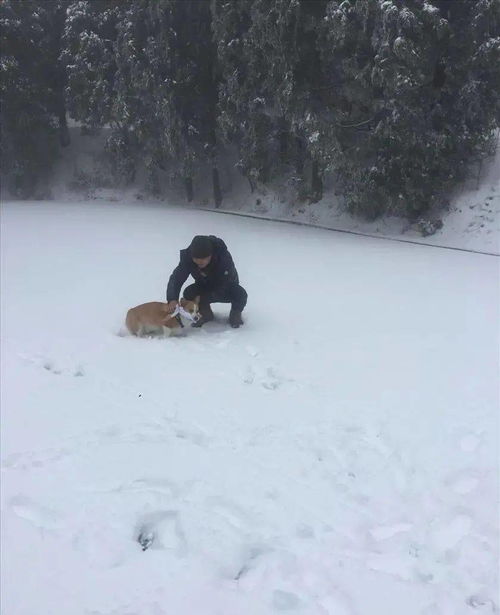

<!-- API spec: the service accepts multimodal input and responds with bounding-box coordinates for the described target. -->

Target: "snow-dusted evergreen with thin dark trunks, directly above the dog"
[125,0,222,205]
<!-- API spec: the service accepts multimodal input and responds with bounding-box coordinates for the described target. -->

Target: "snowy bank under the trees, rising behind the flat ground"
[27,123,500,254]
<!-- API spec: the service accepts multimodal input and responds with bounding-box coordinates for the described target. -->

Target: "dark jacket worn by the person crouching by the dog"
[167,235,239,301]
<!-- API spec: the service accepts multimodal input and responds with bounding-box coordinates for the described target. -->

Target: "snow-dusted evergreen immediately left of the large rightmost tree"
[214,0,326,197]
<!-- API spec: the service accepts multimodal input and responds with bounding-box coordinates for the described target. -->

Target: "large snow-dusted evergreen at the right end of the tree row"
[320,0,500,218]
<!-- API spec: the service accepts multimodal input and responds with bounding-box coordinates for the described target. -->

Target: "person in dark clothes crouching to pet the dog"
[167,235,247,329]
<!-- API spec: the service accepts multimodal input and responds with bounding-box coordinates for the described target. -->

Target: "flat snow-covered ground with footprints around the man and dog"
[1,202,499,615]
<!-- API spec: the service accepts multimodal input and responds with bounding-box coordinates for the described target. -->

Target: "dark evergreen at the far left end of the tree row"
[0,0,69,196]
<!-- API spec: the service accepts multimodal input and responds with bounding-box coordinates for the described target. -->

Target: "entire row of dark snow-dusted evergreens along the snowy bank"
[0,0,500,218]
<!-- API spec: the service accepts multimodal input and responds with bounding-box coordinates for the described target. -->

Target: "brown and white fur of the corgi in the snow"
[125,297,200,337]
